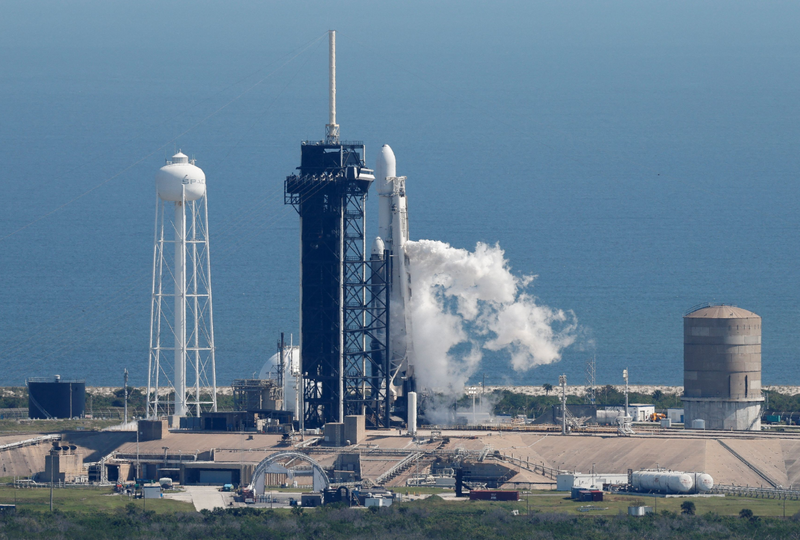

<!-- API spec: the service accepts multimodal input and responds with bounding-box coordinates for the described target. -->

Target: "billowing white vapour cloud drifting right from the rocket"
[405,240,578,393]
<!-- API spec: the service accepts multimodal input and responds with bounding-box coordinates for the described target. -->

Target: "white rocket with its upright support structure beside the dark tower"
[372,144,414,388]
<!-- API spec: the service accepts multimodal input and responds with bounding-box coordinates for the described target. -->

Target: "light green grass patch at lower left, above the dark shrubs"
[0,487,194,514]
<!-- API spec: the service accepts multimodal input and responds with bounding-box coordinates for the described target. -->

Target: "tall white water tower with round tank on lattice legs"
[147,152,217,418]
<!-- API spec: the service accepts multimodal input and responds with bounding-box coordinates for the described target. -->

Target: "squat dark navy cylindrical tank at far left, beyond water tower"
[27,375,86,418]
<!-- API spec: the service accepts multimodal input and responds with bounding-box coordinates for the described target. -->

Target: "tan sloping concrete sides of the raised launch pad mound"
[0,430,800,489]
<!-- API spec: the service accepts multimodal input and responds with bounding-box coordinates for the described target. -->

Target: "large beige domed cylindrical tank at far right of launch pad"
[683,305,764,430]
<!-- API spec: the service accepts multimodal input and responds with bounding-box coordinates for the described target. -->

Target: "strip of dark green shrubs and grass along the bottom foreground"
[0,488,800,540]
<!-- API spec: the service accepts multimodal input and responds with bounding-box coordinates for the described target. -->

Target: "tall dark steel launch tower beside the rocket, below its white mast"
[284,142,389,427]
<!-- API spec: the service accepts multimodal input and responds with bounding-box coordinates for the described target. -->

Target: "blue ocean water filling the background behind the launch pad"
[0,0,800,385]
